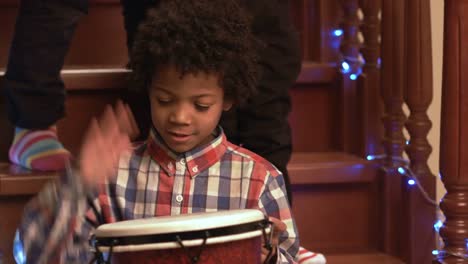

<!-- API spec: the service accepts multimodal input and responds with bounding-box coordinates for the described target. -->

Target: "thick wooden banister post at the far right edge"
[438,0,468,264]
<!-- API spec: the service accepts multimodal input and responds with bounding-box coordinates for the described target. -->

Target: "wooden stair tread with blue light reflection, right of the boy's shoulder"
[288,152,376,184]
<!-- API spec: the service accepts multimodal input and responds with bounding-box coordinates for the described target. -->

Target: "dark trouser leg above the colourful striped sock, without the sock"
[3,0,87,129]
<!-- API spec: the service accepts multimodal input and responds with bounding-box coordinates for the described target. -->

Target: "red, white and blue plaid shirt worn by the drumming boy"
[17,129,299,263]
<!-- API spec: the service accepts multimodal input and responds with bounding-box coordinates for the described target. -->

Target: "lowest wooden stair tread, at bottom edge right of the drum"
[325,252,404,264]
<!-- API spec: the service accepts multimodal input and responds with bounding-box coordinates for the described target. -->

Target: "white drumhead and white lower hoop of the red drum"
[95,209,270,252]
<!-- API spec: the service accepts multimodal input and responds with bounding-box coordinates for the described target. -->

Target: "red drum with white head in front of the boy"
[94,209,271,264]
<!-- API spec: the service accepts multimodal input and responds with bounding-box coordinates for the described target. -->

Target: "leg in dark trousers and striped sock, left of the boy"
[2,0,87,170]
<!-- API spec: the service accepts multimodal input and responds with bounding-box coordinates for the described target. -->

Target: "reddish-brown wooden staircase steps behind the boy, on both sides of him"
[0,0,438,264]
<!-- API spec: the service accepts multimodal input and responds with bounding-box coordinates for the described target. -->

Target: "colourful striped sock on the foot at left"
[9,126,70,171]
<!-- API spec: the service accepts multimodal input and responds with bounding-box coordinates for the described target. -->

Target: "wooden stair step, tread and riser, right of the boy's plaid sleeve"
[288,152,379,253]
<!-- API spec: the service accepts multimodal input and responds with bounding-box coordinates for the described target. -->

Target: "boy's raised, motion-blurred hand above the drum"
[79,101,139,186]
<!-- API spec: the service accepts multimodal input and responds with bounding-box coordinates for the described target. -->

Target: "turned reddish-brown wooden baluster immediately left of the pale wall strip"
[403,0,436,263]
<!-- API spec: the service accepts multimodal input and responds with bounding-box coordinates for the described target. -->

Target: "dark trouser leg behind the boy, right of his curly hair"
[221,0,301,203]
